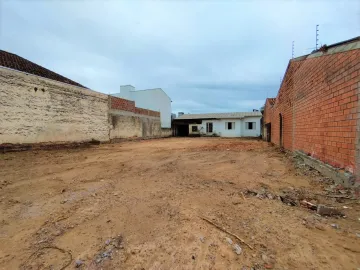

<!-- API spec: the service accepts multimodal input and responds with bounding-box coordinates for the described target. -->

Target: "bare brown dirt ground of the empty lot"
[0,138,360,270]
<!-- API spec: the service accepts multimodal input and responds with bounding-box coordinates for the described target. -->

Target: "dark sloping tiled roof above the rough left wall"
[0,50,86,88]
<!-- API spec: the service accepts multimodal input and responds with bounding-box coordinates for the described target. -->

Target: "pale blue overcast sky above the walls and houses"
[0,0,360,113]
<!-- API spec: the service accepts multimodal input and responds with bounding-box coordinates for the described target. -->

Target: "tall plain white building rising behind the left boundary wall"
[111,85,171,128]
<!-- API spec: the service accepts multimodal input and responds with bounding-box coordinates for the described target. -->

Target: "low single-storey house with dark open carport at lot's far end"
[173,112,262,137]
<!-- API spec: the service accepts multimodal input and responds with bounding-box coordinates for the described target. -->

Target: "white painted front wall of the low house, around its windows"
[195,117,261,137]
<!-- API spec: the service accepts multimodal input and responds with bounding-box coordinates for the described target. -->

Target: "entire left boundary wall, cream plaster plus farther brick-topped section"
[0,67,171,144]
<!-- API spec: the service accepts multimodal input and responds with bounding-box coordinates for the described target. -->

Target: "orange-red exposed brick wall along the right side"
[264,49,360,174]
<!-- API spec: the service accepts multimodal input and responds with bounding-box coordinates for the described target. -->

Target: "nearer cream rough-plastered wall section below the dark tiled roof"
[0,67,109,144]
